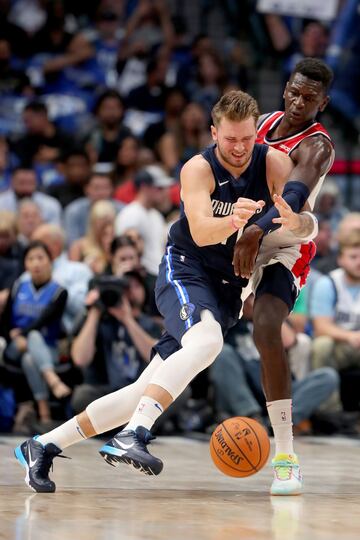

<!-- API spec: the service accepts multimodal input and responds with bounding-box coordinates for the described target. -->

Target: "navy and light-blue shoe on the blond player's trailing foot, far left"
[14,437,70,493]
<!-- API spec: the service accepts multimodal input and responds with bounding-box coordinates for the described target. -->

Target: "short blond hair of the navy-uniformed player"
[211,90,260,127]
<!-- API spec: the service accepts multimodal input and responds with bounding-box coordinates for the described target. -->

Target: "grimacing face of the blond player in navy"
[211,117,256,169]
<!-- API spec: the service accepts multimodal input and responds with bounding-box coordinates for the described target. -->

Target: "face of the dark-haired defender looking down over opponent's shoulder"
[283,73,329,127]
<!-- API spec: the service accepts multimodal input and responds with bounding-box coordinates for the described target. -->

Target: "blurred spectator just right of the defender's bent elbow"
[314,178,348,234]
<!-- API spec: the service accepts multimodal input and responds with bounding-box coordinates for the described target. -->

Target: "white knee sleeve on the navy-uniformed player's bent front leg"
[149,310,224,400]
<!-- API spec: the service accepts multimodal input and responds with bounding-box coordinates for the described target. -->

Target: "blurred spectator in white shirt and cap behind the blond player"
[115,165,174,282]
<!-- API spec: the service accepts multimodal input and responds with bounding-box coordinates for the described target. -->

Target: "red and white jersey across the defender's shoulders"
[256,111,333,155]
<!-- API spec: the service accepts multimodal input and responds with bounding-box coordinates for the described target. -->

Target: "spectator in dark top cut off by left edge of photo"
[0,210,23,313]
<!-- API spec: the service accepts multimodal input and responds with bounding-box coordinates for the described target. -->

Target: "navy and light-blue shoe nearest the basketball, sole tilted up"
[99,426,163,475]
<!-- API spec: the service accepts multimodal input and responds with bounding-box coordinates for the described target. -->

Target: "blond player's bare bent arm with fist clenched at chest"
[181,156,264,247]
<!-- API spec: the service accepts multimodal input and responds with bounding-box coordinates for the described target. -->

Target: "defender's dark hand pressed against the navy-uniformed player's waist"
[233,224,264,279]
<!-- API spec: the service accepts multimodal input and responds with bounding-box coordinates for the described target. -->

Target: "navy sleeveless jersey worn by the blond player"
[168,144,273,285]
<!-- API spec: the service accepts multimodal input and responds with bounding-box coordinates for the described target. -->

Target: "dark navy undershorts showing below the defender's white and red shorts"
[255,263,299,313]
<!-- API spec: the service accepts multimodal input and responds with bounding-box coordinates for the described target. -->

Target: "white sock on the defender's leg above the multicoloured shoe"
[266,399,294,454]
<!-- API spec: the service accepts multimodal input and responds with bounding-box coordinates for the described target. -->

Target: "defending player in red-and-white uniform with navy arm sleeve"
[233,58,334,495]
